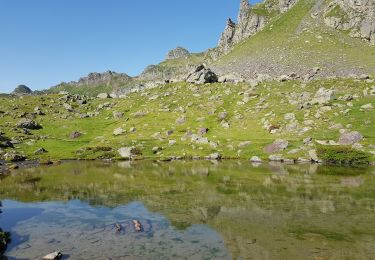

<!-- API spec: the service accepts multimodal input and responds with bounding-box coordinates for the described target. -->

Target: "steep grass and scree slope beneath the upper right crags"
[215,0,375,72]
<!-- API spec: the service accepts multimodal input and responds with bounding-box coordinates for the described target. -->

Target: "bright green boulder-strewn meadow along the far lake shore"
[0,77,375,162]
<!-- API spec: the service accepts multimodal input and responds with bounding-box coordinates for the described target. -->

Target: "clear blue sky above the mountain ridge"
[0,0,255,92]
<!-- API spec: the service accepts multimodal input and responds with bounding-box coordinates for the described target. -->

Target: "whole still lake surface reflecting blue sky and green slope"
[0,161,375,259]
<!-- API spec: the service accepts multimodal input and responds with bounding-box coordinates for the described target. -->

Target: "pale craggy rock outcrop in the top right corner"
[323,0,375,45]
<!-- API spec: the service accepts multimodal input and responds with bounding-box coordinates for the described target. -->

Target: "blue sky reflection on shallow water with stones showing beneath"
[1,201,230,259]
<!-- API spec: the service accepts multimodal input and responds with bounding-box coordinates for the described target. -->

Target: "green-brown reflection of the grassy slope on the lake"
[0,161,375,259]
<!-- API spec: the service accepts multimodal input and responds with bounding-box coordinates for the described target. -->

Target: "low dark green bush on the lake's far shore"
[317,146,370,164]
